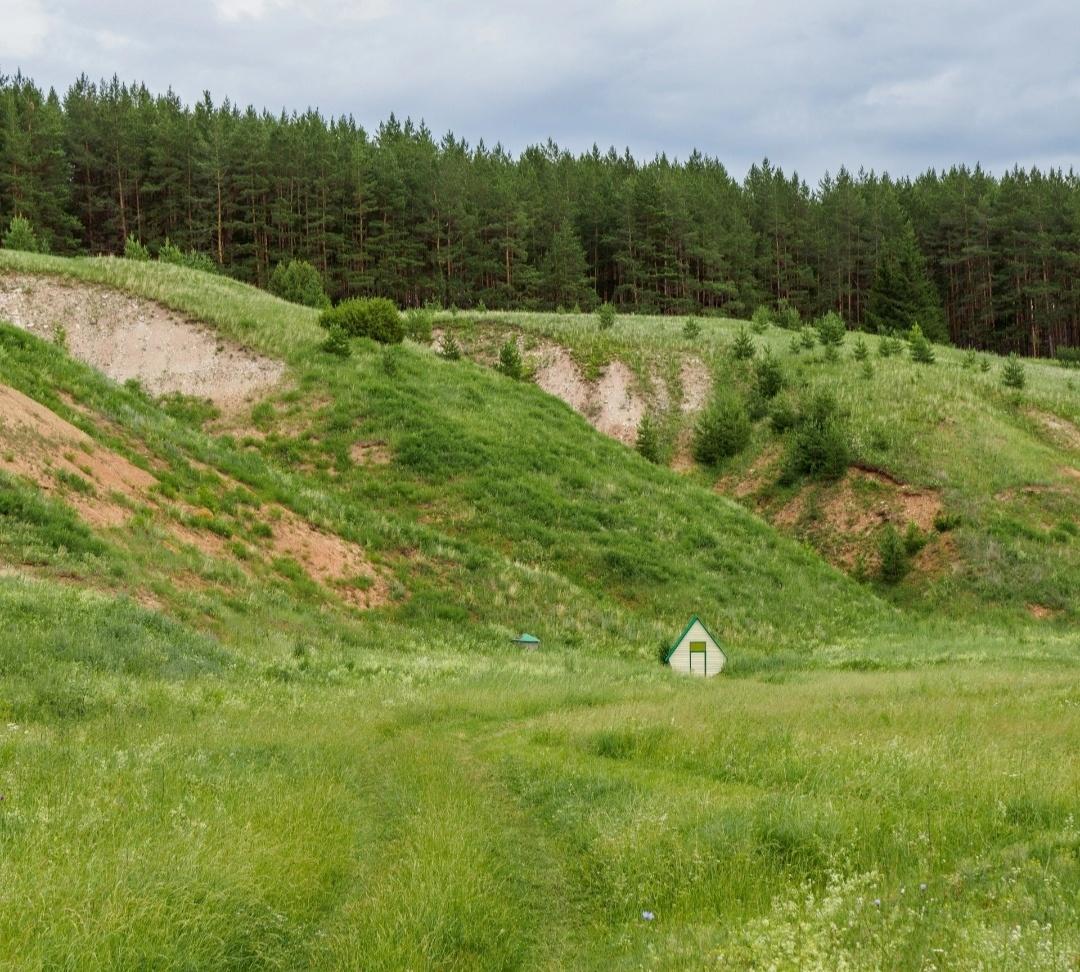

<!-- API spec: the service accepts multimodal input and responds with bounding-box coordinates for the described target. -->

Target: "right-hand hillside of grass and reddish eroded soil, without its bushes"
[440,313,1080,626]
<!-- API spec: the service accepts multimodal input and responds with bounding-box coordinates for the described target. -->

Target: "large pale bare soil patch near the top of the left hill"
[0,274,285,408]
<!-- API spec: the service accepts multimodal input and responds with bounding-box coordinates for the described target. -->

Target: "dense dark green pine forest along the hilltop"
[0,75,1080,354]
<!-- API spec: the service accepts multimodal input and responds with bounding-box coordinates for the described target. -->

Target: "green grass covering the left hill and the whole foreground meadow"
[0,254,1080,969]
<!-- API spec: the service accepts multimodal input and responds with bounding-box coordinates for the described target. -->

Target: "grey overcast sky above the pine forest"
[0,0,1080,181]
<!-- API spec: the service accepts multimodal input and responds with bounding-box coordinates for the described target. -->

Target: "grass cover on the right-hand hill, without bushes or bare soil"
[451,313,1080,626]
